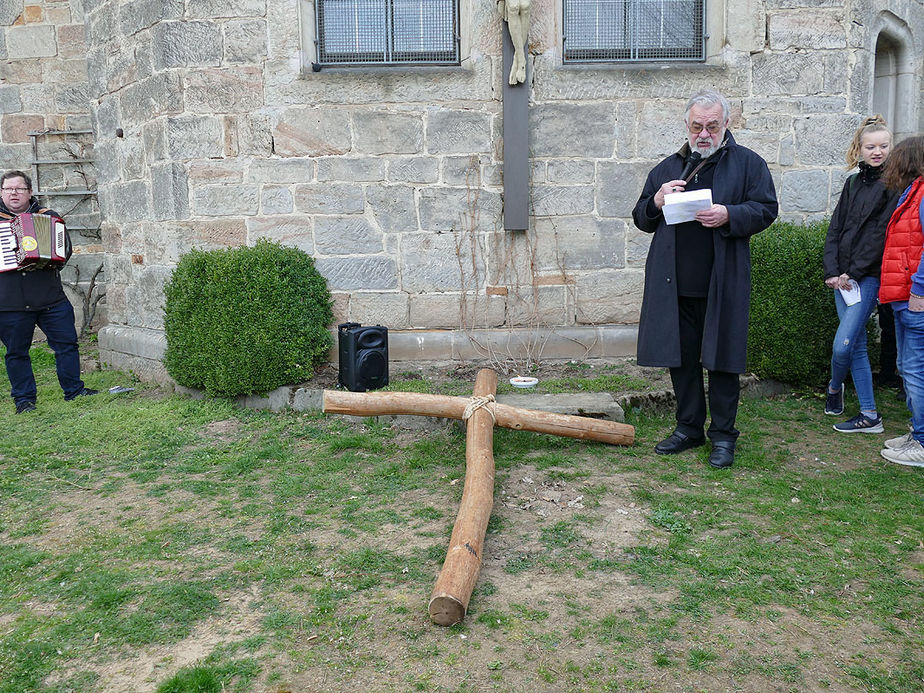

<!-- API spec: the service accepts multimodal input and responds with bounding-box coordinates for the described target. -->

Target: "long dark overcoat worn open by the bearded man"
[632,132,778,373]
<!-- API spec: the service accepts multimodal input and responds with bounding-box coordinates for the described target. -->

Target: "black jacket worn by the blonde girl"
[824,162,900,279]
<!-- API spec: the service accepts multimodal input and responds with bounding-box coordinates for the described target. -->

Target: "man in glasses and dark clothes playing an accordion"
[0,171,96,414]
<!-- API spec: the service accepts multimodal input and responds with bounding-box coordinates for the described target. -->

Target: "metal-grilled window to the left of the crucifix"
[317,0,459,65]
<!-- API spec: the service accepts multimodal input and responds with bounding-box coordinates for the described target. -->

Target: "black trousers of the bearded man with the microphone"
[670,296,740,442]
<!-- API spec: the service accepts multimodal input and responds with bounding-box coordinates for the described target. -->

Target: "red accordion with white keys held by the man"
[0,213,67,272]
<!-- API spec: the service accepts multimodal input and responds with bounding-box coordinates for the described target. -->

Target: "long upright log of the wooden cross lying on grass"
[430,368,497,626]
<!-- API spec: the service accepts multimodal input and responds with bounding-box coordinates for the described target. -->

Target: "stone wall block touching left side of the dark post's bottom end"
[419,187,501,232]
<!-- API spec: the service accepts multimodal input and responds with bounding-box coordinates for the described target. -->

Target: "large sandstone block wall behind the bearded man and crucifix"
[0,0,924,377]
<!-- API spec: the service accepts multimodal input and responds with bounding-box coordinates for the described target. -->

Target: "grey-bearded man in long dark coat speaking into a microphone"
[632,90,777,468]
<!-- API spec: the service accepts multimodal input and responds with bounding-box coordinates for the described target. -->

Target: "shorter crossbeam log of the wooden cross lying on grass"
[322,390,635,445]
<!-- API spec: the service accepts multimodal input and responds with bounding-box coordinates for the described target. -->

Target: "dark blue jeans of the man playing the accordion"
[0,300,83,404]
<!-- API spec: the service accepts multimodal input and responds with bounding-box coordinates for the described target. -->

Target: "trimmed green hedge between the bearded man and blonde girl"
[748,222,844,387]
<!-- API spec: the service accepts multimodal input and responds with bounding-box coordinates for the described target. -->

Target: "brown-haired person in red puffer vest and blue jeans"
[879,136,924,467]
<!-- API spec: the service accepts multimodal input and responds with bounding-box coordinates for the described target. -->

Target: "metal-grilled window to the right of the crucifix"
[563,0,706,63]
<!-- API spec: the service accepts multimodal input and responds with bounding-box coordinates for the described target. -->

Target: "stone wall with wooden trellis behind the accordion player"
[0,0,105,326]
